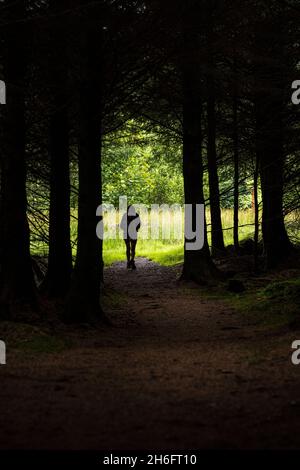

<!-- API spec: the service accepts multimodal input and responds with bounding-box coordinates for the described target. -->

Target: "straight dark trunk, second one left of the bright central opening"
[43,0,72,297]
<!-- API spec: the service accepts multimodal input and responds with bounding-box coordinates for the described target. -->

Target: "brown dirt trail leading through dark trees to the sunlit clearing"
[0,259,300,450]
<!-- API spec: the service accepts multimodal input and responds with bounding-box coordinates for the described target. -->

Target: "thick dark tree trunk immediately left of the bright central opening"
[66,11,102,322]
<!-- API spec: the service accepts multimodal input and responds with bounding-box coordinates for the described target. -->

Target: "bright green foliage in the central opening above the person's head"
[102,123,183,206]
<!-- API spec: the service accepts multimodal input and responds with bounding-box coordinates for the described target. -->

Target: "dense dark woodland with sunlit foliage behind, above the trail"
[0,0,300,322]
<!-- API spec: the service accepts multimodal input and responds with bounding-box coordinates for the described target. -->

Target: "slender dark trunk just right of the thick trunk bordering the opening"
[207,10,225,256]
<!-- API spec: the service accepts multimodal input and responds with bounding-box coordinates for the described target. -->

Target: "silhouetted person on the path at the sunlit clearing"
[120,206,141,269]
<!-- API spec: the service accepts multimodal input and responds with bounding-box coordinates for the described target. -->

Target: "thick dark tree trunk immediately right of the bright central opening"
[182,9,218,284]
